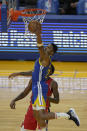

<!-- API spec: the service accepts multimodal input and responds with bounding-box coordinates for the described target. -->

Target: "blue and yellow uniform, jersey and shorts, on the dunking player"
[32,59,51,107]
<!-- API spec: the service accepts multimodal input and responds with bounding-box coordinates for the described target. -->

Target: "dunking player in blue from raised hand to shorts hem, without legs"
[32,23,57,110]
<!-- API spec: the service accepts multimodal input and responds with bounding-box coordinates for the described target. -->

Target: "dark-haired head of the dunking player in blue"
[46,43,57,56]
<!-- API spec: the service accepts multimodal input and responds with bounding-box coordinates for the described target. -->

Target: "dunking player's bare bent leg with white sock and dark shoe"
[34,108,80,127]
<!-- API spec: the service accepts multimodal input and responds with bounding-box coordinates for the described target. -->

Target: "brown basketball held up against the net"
[28,20,41,34]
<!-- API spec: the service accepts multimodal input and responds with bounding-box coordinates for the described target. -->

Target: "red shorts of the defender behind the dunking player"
[23,103,37,130]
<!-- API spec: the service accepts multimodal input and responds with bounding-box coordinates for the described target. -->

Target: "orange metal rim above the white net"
[18,9,47,17]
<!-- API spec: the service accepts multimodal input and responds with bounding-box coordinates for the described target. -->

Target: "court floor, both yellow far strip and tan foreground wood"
[0,61,87,131]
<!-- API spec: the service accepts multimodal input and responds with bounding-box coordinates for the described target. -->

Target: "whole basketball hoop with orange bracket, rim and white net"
[11,9,46,39]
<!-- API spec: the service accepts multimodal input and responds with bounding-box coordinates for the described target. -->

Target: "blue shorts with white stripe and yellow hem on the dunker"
[32,82,48,109]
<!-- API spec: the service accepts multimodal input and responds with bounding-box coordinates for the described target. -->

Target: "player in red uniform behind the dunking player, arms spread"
[9,65,59,131]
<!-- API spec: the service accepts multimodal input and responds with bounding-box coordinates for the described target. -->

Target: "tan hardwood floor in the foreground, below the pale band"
[0,88,87,131]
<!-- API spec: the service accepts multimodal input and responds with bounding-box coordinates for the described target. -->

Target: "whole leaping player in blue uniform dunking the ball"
[29,21,80,130]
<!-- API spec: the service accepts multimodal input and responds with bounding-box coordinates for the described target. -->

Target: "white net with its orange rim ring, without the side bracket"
[22,9,46,41]
